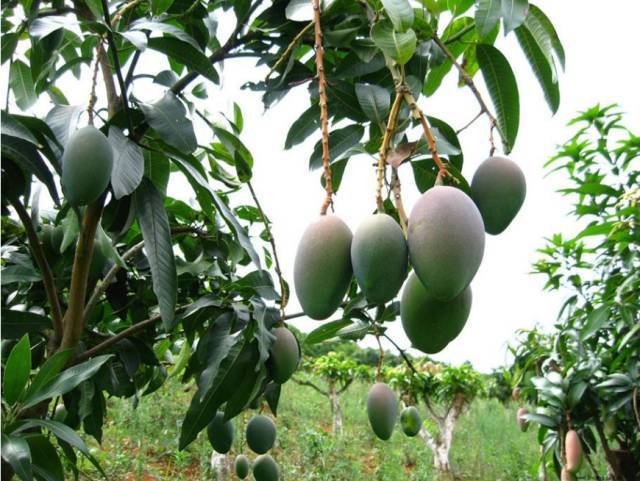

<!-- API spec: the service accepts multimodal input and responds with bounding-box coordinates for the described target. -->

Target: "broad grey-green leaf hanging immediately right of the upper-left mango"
[108,126,144,199]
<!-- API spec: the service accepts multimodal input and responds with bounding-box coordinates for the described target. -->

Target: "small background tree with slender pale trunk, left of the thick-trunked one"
[293,352,373,434]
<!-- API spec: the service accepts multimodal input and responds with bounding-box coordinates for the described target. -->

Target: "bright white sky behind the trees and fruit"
[0,0,640,371]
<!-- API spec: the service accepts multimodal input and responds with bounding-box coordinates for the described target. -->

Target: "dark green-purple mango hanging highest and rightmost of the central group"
[471,156,527,235]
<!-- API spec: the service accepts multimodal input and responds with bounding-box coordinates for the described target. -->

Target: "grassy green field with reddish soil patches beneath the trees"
[82,376,556,481]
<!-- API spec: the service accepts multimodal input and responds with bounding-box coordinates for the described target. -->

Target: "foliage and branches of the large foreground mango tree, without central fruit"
[1,0,564,479]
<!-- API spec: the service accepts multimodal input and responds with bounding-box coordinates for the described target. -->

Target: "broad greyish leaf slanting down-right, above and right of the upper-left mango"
[140,92,198,153]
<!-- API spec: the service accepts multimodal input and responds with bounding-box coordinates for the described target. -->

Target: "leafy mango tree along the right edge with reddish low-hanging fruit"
[511,106,640,481]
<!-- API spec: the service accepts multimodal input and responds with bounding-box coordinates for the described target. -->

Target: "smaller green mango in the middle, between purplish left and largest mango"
[351,214,408,304]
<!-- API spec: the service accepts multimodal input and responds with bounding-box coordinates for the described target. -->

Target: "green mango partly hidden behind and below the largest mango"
[400,273,472,354]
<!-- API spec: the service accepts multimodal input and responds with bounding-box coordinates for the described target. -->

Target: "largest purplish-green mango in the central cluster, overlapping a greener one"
[408,186,484,301]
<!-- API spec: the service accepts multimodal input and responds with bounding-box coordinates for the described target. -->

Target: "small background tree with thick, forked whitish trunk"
[386,361,484,472]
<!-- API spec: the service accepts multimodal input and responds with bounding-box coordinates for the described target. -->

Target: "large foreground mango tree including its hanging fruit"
[1,0,564,480]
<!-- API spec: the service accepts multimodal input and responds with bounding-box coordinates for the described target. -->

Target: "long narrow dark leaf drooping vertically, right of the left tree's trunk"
[135,179,178,331]
